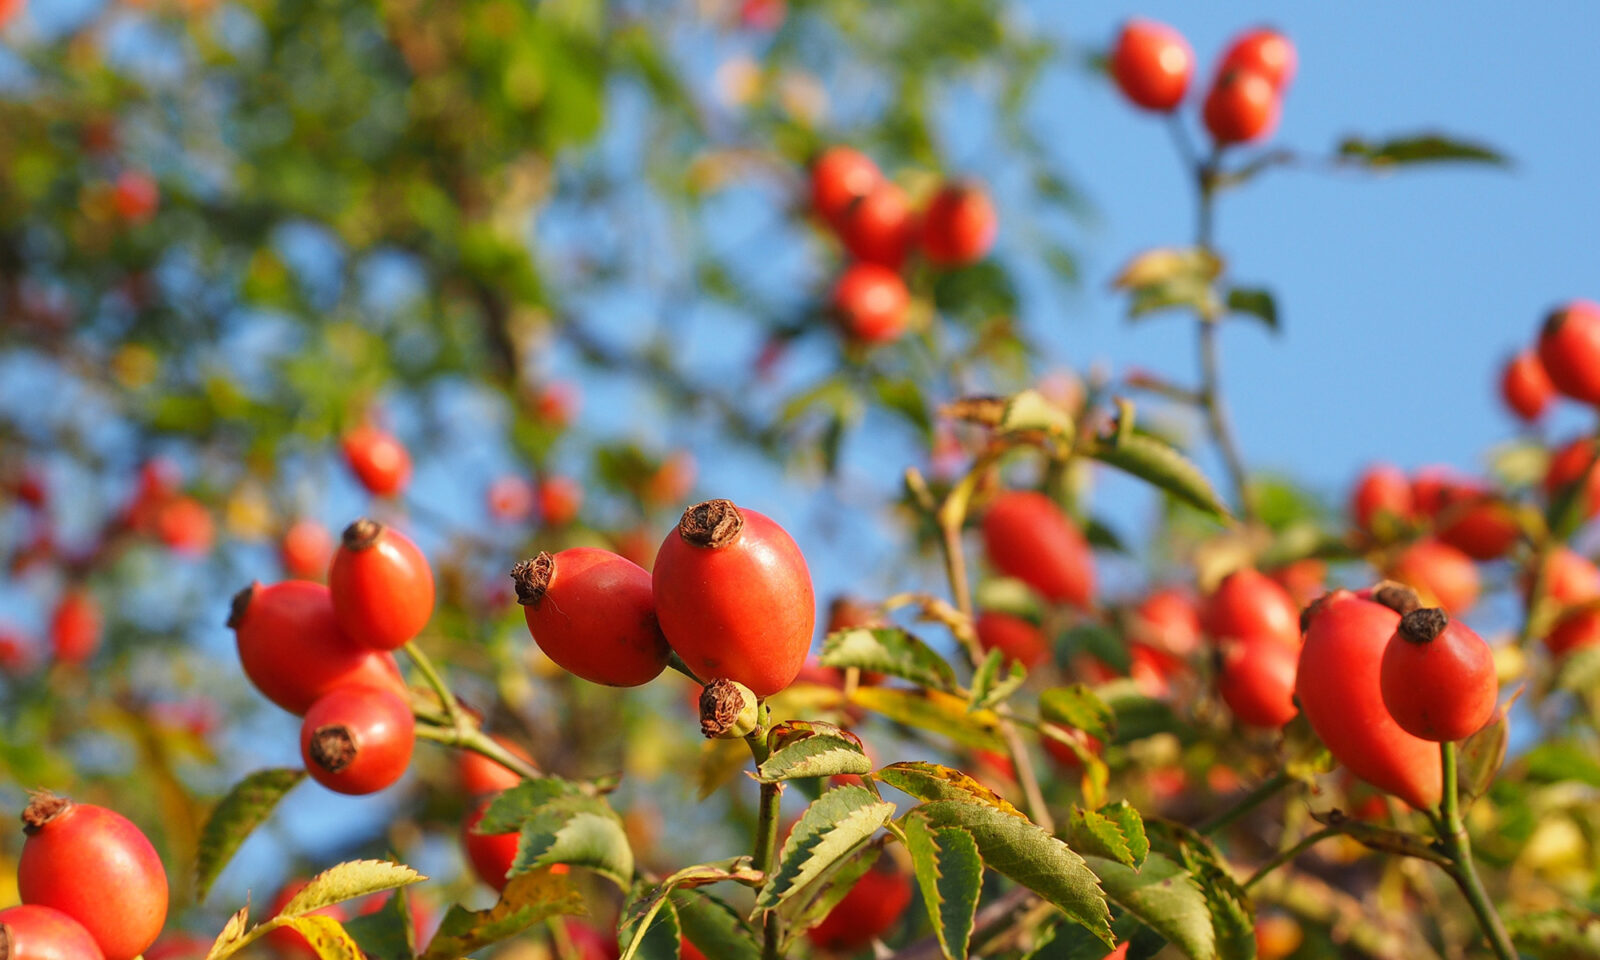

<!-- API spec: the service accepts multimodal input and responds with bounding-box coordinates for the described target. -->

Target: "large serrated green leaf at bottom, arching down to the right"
[915,800,1110,946]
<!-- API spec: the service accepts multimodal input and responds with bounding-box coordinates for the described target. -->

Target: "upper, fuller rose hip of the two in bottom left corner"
[16,794,166,960]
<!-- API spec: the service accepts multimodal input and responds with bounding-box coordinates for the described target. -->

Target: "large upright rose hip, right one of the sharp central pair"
[653,499,816,696]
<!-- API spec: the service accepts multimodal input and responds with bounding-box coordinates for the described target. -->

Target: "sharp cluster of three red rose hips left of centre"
[229,518,434,794]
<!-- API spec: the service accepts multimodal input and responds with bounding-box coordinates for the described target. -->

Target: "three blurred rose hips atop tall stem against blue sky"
[1110,19,1296,147]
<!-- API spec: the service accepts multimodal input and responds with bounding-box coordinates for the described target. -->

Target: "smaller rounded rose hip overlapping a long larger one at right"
[1379,606,1499,742]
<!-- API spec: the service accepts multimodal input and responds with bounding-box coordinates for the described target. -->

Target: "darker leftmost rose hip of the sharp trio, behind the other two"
[227,581,405,715]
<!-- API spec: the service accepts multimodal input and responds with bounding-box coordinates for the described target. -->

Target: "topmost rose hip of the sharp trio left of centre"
[328,517,434,650]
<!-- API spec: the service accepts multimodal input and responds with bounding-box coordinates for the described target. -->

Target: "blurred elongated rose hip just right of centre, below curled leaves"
[982,490,1094,606]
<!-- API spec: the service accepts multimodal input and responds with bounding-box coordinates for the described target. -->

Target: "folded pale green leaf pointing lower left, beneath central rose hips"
[755,786,894,914]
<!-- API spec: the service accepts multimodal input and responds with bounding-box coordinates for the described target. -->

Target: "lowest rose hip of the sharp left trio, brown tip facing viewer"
[301,686,416,797]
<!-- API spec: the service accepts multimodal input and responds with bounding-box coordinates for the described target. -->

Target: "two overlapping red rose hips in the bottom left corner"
[0,794,166,960]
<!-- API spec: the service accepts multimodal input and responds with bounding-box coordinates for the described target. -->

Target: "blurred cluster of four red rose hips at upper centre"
[811,146,998,344]
